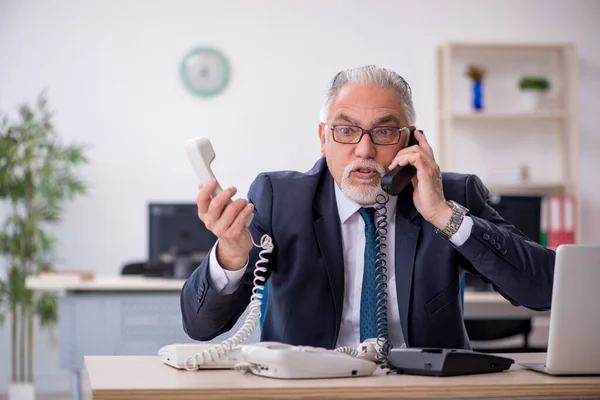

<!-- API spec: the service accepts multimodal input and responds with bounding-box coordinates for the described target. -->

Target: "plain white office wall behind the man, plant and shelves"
[0,0,600,393]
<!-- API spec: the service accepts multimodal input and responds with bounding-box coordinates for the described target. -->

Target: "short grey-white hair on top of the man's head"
[320,65,416,125]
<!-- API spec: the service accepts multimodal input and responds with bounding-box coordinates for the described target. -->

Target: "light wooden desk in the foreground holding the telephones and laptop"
[85,353,600,400]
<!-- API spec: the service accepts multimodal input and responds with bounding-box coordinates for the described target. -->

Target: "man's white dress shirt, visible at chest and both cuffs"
[208,183,473,348]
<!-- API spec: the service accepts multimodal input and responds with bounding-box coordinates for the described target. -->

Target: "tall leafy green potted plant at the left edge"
[0,93,87,400]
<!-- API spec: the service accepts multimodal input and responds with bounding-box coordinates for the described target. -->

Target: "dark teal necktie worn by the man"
[358,207,377,343]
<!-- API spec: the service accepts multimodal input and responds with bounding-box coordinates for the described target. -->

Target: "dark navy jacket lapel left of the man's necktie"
[313,164,344,347]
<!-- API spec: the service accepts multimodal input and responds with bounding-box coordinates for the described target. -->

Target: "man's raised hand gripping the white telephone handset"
[196,179,254,271]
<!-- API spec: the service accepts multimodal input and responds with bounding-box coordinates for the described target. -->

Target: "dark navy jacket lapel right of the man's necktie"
[395,185,421,347]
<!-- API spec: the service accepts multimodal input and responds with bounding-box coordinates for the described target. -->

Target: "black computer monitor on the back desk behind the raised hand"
[148,203,217,262]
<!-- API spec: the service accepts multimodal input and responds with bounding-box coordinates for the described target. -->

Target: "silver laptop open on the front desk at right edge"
[519,245,600,375]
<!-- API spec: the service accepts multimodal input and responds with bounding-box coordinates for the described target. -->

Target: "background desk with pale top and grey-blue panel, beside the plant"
[26,275,260,400]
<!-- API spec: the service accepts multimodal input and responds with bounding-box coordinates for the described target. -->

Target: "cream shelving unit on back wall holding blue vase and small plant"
[436,42,581,242]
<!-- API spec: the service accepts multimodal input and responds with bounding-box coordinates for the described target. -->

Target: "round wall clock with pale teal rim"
[180,47,229,96]
